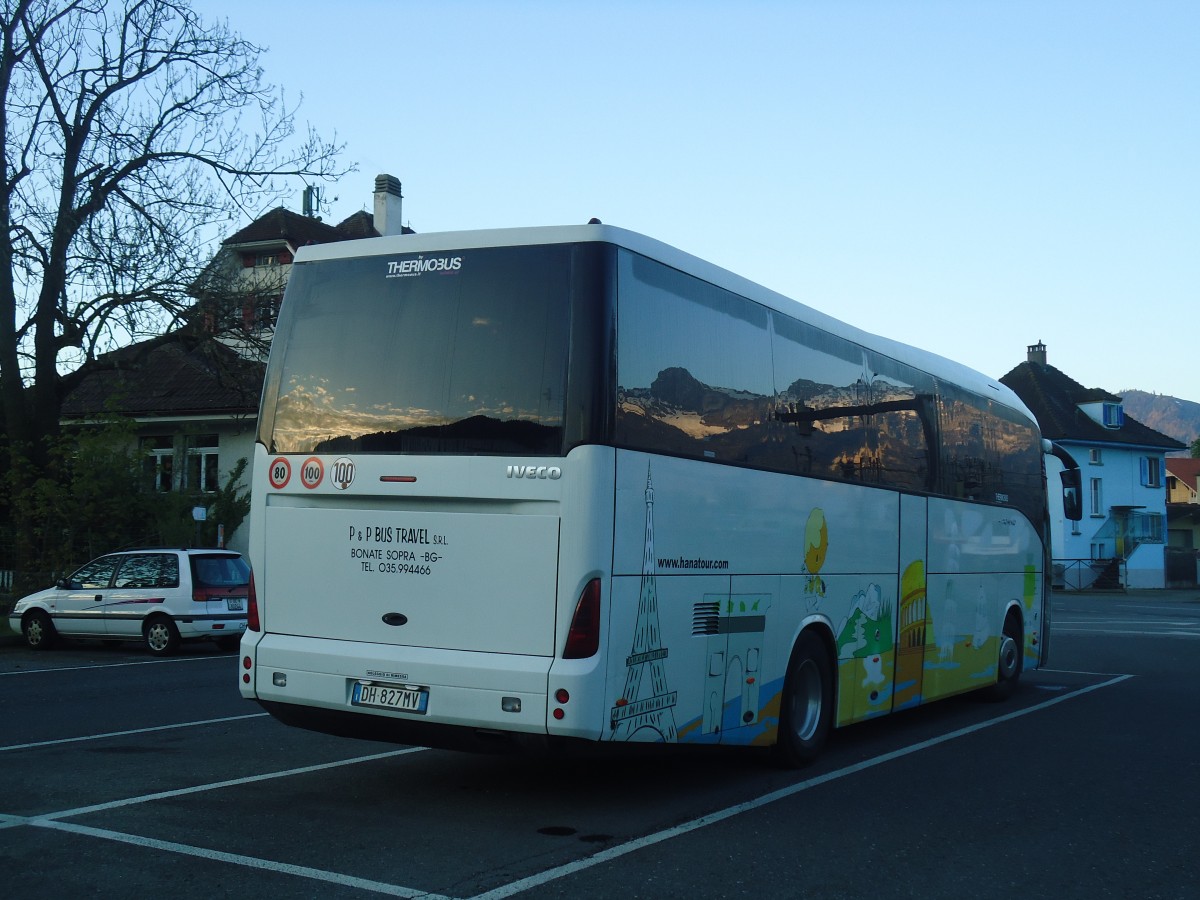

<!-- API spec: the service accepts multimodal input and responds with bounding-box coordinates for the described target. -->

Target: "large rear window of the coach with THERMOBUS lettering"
[258,246,571,455]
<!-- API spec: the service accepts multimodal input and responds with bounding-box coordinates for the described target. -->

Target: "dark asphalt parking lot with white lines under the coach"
[0,592,1200,900]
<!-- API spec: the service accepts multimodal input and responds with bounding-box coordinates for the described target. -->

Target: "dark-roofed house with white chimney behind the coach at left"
[62,175,412,552]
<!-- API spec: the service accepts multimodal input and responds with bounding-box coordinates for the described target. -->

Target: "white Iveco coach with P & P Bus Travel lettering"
[239,222,1078,766]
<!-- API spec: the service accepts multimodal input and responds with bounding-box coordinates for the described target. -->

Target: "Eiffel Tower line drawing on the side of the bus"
[608,466,678,743]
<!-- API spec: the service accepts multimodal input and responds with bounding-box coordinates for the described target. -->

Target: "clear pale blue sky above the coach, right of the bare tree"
[193,0,1200,401]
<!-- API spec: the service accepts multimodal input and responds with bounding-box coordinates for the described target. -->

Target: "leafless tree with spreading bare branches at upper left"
[0,0,353,465]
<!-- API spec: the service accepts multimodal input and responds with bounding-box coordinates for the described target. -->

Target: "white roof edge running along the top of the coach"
[295,223,1034,421]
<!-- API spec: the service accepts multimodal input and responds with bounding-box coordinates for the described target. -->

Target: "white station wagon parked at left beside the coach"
[8,550,250,656]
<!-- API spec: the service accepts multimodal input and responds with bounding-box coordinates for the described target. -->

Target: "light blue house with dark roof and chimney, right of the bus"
[1000,341,1186,588]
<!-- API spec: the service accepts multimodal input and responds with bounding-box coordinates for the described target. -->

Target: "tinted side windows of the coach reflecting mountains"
[614,248,1042,522]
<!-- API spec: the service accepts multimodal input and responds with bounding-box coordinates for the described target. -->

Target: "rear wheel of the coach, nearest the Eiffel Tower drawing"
[775,629,833,768]
